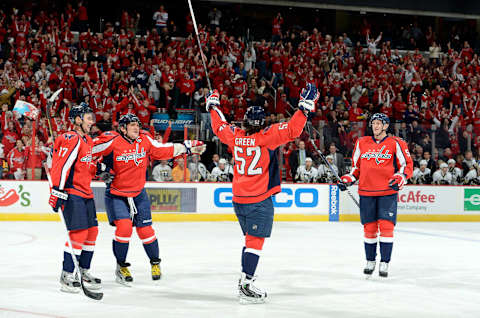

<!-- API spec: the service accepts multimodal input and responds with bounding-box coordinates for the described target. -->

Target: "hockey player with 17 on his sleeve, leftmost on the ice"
[49,105,101,293]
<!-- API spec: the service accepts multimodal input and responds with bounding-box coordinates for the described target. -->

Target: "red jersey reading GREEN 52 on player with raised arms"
[210,109,307,203]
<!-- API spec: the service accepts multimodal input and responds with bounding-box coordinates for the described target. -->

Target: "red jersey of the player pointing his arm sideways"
[93,131,185,197]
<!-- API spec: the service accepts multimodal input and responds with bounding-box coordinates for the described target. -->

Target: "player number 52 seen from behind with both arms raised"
[206,84,319,303]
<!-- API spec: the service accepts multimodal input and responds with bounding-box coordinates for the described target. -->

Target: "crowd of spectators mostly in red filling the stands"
[0,2,480,184]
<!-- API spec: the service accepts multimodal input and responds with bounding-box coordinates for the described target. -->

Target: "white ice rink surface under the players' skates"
[0,222,480,318]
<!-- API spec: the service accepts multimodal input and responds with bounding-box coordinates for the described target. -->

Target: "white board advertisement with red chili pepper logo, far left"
[0,180,51,213]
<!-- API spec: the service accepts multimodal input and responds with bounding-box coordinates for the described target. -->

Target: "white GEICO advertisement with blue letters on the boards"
[199,183,329,214]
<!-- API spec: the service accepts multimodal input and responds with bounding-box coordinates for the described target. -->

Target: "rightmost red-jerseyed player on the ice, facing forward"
[339,113,413,277]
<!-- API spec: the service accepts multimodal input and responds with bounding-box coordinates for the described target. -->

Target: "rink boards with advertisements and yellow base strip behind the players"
[0,180,480,222]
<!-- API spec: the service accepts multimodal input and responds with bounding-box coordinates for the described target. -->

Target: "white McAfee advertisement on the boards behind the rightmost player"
[340,185,464,214]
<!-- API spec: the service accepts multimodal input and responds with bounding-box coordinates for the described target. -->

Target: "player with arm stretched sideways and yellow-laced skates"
[92,114,205,286]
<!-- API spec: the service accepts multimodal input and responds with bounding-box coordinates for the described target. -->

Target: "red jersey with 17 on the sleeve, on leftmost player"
[51,131,97,198]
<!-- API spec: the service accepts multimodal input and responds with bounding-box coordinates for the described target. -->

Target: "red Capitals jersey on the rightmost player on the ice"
[350,136,413,196]
